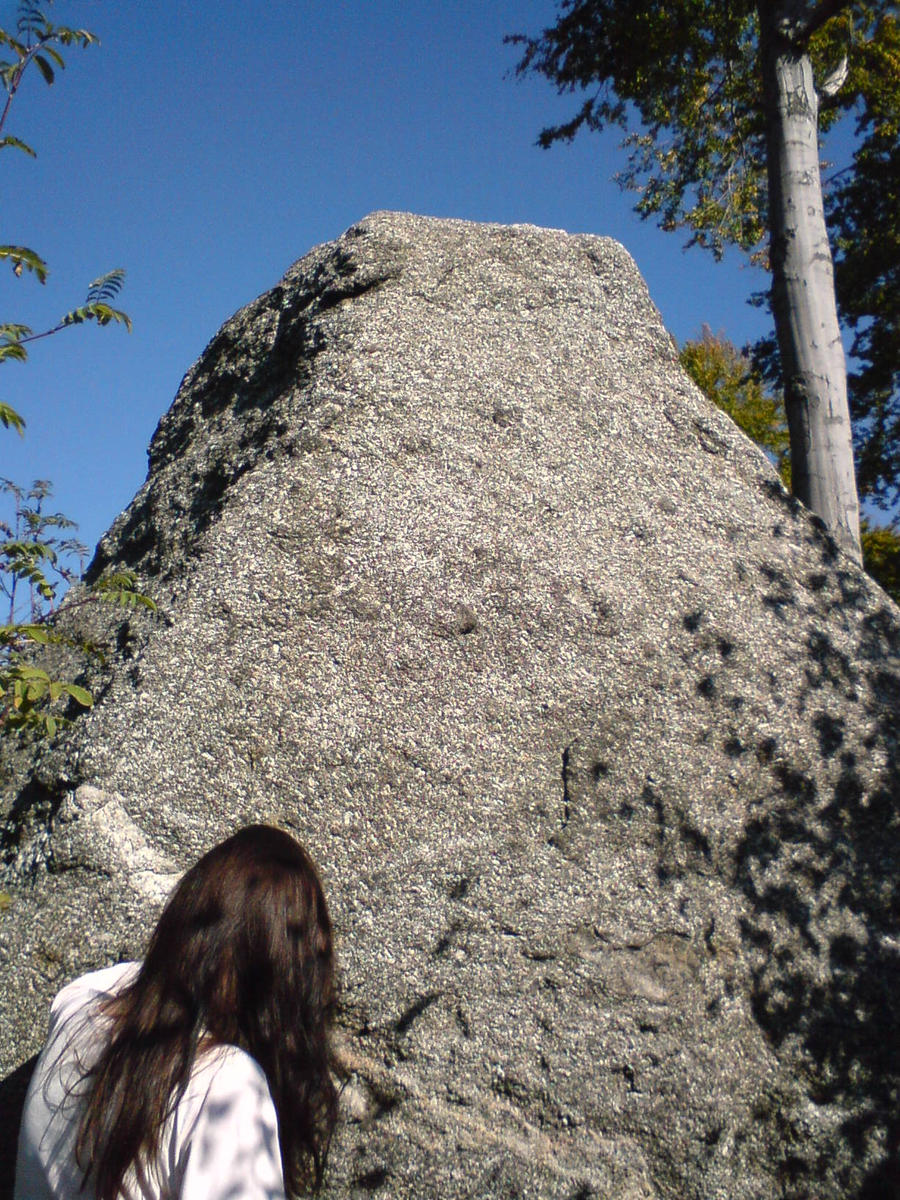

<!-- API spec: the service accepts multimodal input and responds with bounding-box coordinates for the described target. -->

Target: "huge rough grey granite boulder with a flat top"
[0,214,900,1200]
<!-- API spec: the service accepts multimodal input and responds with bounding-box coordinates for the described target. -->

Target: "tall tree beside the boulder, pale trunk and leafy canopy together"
[509,0,900,556]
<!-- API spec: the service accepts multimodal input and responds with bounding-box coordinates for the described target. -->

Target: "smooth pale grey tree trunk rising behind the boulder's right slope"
[757,0,862,562]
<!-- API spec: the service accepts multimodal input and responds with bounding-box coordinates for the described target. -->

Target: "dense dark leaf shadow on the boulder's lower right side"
[737,598,900,1200]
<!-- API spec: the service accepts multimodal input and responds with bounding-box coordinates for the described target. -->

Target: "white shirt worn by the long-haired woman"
[13,962,284,1200]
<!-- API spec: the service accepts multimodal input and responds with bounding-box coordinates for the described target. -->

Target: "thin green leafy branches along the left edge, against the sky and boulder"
[0,0,156,738]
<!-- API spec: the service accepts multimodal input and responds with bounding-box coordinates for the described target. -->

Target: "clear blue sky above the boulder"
[0,0,801,547]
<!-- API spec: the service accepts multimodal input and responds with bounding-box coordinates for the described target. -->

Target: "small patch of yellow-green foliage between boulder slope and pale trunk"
[679,326,791,486]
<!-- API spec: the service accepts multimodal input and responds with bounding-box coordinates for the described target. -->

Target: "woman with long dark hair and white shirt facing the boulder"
[14,826,337,1200]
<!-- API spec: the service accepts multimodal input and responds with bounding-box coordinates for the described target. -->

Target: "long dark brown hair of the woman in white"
[76,826,337,1200]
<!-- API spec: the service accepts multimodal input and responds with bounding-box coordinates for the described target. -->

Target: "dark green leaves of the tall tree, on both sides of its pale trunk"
[506,0,900,535]
